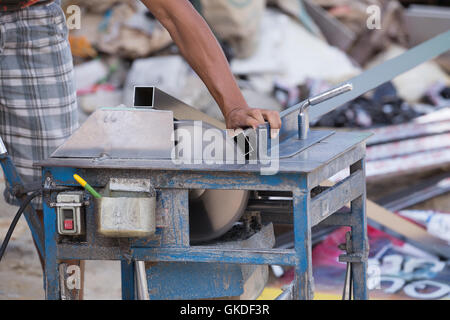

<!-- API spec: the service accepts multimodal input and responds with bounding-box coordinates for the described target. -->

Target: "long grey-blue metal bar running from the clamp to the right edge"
[280,30,450,140]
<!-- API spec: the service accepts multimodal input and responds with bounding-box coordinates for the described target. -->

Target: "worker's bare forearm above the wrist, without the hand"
[143,0,248,116]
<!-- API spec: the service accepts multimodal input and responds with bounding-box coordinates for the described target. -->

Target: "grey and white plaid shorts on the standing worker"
[0,3,78,208]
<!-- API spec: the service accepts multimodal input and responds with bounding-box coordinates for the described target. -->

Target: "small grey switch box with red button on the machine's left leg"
[56,192,85,236]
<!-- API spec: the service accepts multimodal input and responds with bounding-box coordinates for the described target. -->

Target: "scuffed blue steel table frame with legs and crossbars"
[36,132,370,299]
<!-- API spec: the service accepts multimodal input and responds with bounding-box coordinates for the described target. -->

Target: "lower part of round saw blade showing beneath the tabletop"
[189,189,250,243]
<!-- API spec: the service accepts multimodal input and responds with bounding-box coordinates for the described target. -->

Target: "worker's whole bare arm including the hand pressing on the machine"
[142,0,281,134]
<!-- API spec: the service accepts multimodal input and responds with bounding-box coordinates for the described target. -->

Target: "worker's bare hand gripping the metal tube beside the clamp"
[225,107,281,138]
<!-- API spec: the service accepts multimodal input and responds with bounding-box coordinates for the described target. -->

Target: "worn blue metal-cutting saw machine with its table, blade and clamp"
[36,84,370,299]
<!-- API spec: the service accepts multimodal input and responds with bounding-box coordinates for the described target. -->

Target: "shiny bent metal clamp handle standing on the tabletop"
[298,83,353,140]
